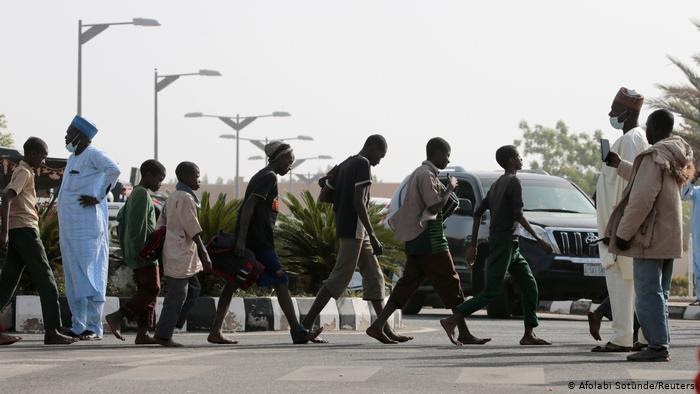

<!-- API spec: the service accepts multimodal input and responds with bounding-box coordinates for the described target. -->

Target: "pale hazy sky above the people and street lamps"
[0,0,700,181]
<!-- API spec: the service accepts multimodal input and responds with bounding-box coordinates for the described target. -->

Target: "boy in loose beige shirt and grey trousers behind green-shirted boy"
[154,161,211,347]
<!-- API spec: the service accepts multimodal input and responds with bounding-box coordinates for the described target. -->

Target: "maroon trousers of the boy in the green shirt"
[121,265,160,330]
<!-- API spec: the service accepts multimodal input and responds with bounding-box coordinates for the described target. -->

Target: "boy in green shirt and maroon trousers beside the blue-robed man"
[105,160,165,345]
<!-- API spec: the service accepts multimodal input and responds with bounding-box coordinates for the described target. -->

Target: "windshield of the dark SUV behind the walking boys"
[481,178,595,214]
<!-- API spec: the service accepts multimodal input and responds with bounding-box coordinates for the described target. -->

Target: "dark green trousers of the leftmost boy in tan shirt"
[0,227,61,331]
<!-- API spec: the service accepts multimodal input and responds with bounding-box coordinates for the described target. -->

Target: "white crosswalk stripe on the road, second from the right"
[456,367,545,385]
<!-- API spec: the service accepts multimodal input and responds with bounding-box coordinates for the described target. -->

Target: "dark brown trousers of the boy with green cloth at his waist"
[389,251,464,309]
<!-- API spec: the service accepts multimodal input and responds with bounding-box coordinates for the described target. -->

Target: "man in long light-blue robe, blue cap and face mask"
[58,116,120,341]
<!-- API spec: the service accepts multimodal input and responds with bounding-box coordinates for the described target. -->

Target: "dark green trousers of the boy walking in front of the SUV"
[455,239,539,327]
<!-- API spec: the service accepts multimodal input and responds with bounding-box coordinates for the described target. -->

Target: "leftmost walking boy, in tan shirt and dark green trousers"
[0,137,77,345]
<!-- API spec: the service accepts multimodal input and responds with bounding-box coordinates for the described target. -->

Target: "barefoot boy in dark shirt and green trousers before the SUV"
[440,145,552,345]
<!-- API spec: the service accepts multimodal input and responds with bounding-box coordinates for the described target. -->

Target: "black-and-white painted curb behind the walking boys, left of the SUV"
[0,296,402,333]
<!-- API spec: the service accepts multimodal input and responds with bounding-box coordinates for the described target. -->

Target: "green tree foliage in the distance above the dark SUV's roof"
[514,121,602,195]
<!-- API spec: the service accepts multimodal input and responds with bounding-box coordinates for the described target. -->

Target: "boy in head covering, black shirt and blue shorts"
[208,141,320,344]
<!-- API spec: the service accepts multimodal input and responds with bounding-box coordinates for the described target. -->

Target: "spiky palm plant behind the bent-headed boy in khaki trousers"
[275,191,401,293]
